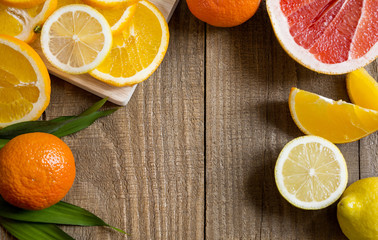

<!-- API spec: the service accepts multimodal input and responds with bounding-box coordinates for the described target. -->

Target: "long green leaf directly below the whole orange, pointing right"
[0,198,126,234]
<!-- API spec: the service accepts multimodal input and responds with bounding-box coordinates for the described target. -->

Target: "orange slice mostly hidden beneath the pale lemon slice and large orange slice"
[58,0,137,35]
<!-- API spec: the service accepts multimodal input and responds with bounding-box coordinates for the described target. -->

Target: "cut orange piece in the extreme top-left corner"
[0,0,57,42]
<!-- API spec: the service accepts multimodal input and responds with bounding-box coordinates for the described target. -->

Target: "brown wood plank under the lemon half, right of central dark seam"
[206,1,359,239]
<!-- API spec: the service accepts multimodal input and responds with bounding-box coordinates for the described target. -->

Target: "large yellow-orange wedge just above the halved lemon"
[289,88,378,143]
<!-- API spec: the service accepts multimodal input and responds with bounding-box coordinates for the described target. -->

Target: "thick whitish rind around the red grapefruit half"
[266,0,378,75]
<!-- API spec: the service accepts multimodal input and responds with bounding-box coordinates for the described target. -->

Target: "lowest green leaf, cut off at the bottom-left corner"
[0,218,74,240]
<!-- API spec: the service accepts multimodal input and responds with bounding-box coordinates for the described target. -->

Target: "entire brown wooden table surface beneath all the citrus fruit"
[0,1,378,240]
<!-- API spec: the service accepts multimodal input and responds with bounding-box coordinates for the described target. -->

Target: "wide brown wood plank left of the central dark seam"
[0,1,204,240]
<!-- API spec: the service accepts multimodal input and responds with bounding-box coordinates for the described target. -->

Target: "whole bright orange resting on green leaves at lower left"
[0,133,76,210]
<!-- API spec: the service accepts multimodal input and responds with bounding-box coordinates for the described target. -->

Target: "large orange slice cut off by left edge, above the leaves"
[0,35,51,128]
